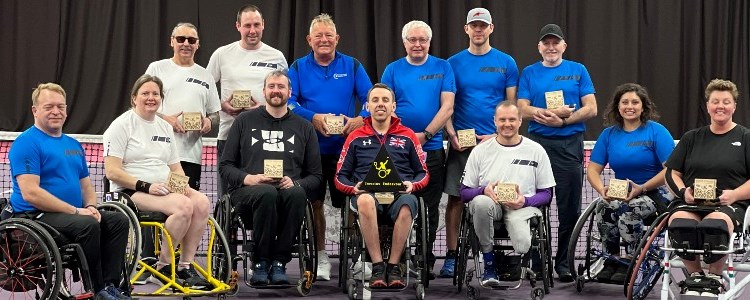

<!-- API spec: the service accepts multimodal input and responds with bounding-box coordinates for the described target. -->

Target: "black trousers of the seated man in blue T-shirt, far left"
[36,211,130,291]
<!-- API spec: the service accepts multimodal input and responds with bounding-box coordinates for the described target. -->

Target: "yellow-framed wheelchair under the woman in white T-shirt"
[102,192,236,300]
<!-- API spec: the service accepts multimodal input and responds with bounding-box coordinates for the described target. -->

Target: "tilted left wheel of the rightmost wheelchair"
[625,214,669,300]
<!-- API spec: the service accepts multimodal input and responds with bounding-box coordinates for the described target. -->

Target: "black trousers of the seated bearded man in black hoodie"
[230,184,307,263]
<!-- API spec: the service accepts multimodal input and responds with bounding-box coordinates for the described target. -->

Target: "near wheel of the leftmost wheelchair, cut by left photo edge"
[0,218,63,299]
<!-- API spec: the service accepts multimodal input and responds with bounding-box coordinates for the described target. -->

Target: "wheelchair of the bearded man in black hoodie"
[214,194,318,296]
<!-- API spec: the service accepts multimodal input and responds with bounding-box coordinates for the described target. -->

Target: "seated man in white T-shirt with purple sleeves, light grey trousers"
[460,101,555,286]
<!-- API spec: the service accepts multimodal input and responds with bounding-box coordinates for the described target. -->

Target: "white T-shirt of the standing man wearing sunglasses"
[146,58,221,164]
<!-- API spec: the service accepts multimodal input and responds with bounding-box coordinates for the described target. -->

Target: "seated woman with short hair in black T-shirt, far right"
[666,79,750,297]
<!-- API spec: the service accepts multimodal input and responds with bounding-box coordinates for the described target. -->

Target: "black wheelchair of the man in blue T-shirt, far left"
[0,198,133,300]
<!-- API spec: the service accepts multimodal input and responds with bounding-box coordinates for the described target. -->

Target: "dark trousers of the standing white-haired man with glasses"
[418,149,445,270]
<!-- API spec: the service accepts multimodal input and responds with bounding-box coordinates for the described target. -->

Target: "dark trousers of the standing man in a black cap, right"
[529,133,583,274]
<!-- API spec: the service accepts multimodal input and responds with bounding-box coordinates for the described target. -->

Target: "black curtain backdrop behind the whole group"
[0,0,750,140]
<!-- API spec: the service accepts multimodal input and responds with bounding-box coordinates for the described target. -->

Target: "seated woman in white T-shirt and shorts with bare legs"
[103,75,213,289]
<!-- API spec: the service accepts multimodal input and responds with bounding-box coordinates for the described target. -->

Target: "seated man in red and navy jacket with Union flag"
[335,83,429,288]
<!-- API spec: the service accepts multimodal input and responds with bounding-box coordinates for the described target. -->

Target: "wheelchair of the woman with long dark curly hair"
[568,198,665,293]
